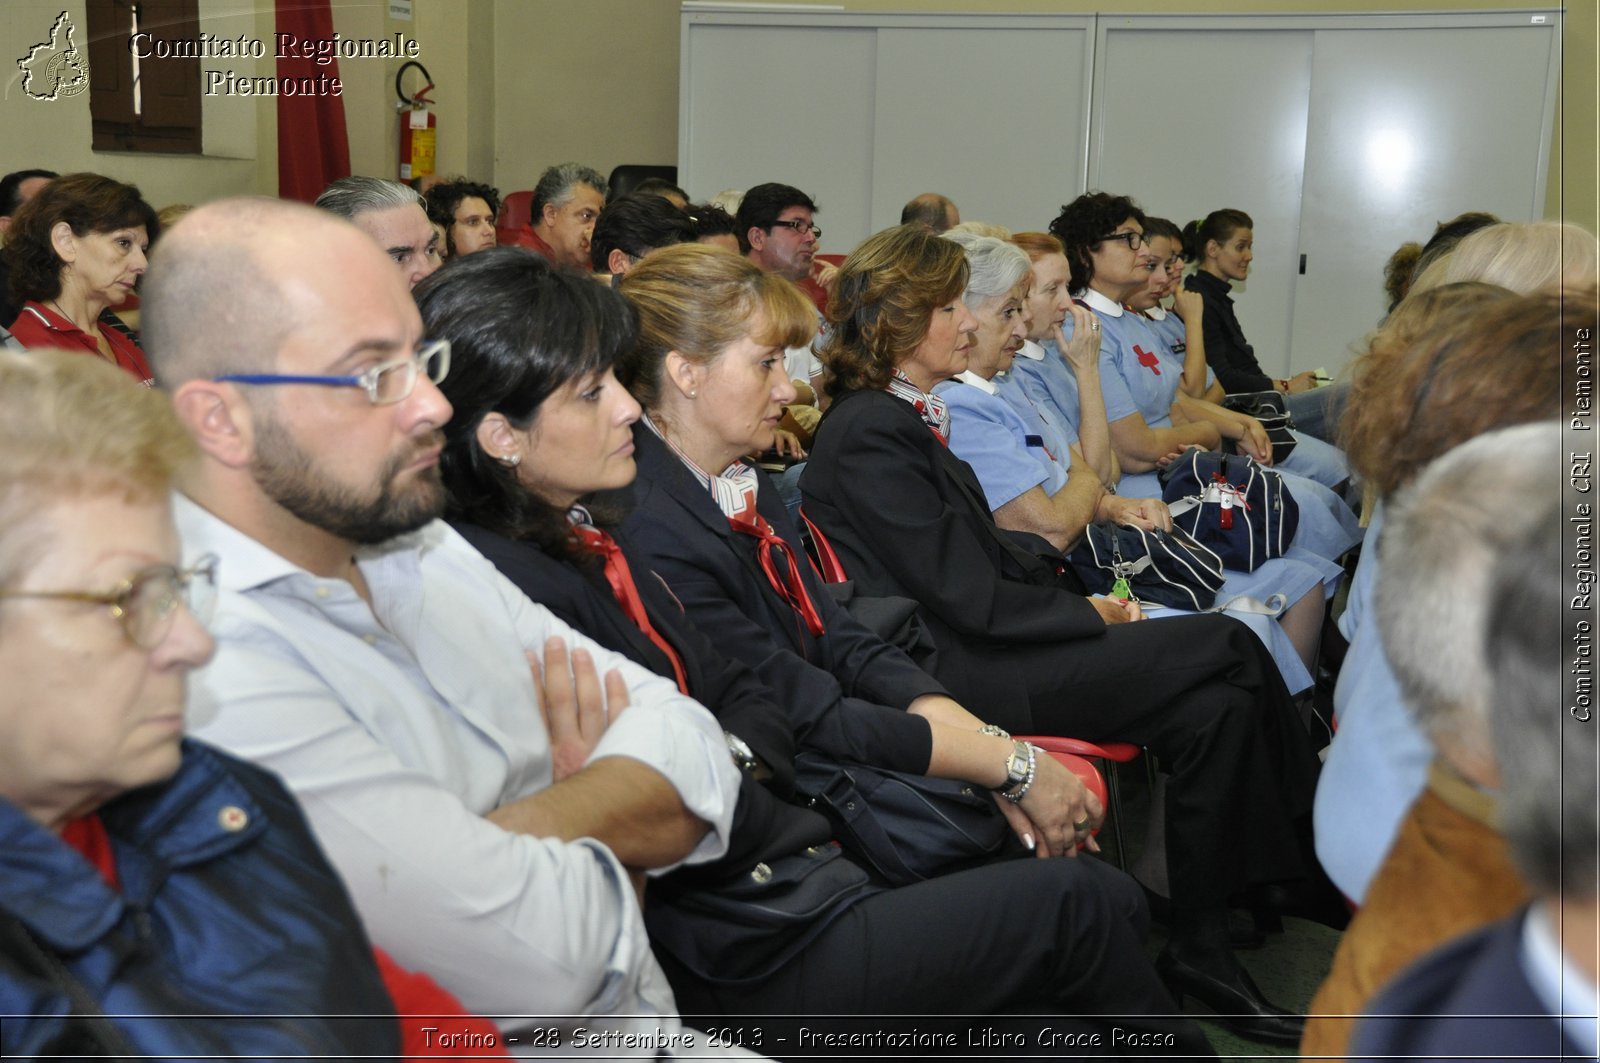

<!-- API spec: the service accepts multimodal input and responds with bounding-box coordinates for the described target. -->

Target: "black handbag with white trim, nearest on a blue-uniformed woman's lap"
[1067,520,1227,612]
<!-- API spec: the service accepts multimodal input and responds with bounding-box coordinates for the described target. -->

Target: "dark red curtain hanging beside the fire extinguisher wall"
[277,0,350,203]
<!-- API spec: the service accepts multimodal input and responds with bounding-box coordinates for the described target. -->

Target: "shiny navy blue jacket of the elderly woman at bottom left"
[0,741,400,1058]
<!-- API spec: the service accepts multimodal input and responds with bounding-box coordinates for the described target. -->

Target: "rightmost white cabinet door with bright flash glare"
[1286,14,1558,373]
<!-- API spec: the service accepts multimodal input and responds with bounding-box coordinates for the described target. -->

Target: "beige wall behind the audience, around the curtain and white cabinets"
[0,0,1600,229]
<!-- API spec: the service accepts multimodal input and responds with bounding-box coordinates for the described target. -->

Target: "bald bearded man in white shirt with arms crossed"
[144,200,738,1055]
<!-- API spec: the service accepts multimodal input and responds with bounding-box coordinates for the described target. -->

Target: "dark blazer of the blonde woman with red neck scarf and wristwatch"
[622,423,946,773]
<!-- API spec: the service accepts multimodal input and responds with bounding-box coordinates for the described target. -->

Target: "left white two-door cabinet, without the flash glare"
[678,8,1094,255]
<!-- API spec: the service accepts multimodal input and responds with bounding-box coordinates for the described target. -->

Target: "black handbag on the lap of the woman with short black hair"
[645,844,882,985]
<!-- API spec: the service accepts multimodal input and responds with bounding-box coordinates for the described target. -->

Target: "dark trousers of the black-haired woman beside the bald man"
[658,856,1210,1055]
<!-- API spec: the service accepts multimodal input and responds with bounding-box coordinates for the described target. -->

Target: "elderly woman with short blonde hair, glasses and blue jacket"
[0,351,492,1058]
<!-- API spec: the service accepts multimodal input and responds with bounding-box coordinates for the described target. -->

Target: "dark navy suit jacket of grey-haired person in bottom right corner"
[1349,909,1582,1063]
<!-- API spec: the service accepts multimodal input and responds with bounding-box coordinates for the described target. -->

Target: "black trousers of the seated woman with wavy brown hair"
[984,615,1318,908]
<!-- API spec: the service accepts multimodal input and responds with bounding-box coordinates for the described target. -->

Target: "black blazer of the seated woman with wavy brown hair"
[800,391,1106,719]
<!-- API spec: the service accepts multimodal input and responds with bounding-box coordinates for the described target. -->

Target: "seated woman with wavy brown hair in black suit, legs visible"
[800,226,1317,1041]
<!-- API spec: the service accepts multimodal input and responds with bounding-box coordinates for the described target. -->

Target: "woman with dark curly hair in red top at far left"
[5,173,162,384]
